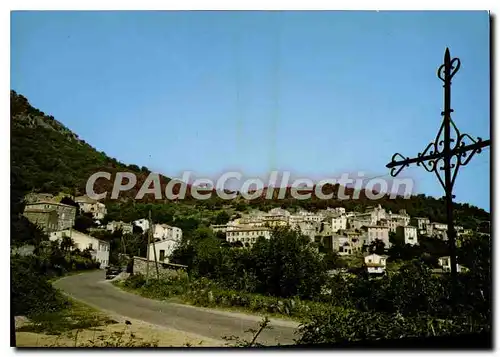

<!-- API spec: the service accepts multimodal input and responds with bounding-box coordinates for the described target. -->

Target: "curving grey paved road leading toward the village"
[54,271,298,345]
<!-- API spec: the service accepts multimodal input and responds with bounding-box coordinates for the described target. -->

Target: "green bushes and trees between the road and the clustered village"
[116,225,491,343]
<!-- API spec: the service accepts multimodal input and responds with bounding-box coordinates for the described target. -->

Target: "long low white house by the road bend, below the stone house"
[49,229,110,269]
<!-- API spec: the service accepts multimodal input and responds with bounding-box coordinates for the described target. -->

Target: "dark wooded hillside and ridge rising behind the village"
[10,91,490,227]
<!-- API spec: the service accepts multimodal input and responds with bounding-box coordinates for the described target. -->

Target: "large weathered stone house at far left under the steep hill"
[23,201,76,232]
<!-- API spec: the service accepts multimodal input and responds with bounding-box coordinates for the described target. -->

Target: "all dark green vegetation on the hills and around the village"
[11,91,491,343]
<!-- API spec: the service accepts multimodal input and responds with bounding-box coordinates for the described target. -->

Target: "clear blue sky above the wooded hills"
[11,11,490,210]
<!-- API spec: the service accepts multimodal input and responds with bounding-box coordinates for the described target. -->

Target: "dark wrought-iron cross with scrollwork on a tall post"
[386,48,490,302]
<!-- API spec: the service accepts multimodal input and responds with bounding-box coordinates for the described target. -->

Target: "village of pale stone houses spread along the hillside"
[17,194,484,275]
